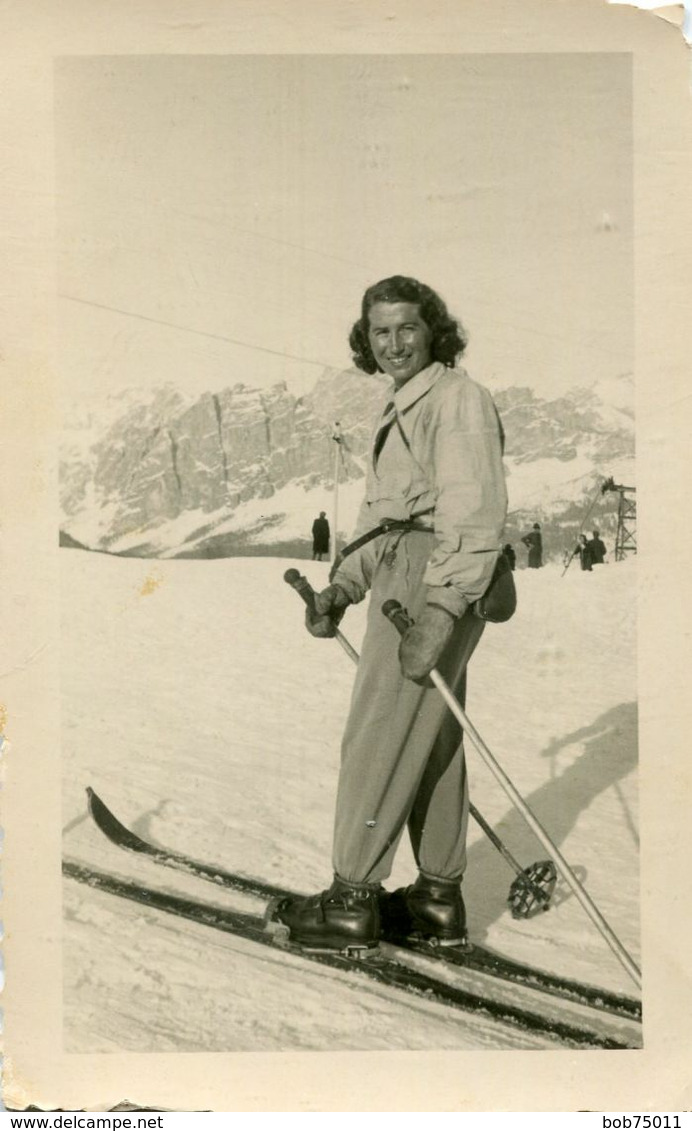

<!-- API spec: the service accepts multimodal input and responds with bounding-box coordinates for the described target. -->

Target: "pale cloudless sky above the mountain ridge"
[55,54,633,400]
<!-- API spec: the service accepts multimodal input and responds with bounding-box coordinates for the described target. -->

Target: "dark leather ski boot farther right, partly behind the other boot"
[380,873,468,947]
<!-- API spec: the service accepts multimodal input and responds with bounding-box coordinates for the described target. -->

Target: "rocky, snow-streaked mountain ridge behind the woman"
[60,370,634,556]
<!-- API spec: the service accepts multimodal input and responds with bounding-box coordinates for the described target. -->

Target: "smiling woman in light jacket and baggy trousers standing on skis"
[264,276,507,953]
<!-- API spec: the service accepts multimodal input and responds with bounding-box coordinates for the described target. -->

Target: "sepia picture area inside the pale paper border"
[54,51,646,1054]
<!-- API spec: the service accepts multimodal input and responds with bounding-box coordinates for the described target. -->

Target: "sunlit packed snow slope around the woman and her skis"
[61,550,639,1053]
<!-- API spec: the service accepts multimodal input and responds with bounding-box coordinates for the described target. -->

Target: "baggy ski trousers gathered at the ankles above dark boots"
[332,530,485,883]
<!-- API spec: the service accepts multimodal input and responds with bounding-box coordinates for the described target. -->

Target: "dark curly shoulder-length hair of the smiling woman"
[348,275,468,373]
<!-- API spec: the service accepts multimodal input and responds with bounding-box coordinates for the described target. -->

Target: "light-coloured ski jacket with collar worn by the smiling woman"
[334,362,507,616]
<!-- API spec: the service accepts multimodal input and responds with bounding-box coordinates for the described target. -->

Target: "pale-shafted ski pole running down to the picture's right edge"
[382,601,641,990]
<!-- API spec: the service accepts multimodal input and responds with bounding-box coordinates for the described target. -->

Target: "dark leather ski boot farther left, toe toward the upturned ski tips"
[266,877,380,959]
